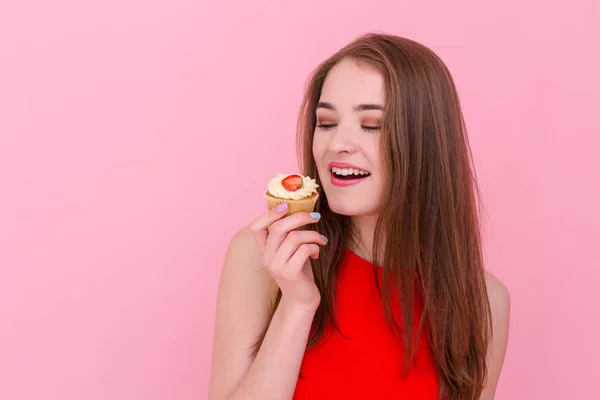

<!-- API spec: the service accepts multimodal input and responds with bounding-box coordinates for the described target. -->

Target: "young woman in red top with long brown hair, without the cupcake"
[209,34,510,400]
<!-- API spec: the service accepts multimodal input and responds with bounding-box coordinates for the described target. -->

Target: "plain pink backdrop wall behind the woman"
[0,0,600,400]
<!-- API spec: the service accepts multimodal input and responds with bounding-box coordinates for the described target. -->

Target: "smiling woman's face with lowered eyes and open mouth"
[313,60,385,216]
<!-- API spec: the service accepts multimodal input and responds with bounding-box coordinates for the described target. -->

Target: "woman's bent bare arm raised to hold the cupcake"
[209,206,324,400]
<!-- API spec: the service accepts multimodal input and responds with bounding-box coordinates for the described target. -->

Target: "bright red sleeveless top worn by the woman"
[294,250,439,400]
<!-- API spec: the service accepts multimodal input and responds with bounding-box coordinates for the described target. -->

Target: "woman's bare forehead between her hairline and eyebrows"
[320,59,385,107]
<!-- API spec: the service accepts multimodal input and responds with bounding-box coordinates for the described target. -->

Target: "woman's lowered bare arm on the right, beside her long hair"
[480,274,510,400]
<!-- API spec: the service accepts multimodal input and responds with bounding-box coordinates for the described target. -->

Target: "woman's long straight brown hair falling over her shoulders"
[258,34,491,400]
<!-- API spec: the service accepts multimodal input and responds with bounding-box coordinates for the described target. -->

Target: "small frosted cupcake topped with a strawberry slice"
[265,174,319,215]
